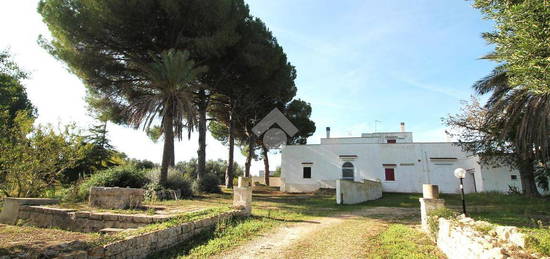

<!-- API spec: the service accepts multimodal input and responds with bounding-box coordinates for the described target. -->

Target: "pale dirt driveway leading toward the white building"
[219,207,418,258]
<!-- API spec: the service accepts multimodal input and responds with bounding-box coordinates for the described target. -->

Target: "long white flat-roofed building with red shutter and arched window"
[281,123,521,193]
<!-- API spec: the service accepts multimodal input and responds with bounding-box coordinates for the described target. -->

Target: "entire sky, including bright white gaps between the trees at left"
[0,0,494,175]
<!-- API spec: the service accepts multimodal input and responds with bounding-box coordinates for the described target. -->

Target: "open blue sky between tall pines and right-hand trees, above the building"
[248,0,494,142]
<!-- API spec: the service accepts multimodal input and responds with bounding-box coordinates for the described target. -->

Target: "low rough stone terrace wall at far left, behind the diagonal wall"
[18,206,174,232]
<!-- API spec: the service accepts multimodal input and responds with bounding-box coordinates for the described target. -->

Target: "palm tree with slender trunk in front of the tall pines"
[127,49,206,185]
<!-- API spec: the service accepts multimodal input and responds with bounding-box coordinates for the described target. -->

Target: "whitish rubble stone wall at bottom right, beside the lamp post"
[437,216,538,259]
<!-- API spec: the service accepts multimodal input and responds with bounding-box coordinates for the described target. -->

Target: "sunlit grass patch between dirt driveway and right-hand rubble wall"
[367,224,445,258]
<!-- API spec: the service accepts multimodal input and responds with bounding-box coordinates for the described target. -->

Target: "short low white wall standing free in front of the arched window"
[336,179,382,204]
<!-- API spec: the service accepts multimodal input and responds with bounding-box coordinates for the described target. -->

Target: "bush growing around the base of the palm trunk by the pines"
[146,168,193,197]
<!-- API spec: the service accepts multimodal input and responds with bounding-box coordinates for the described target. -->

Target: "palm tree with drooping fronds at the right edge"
[474,66,550,196]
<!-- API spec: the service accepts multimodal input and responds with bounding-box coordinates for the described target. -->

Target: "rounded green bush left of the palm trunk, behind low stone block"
[79,165,149,199]
